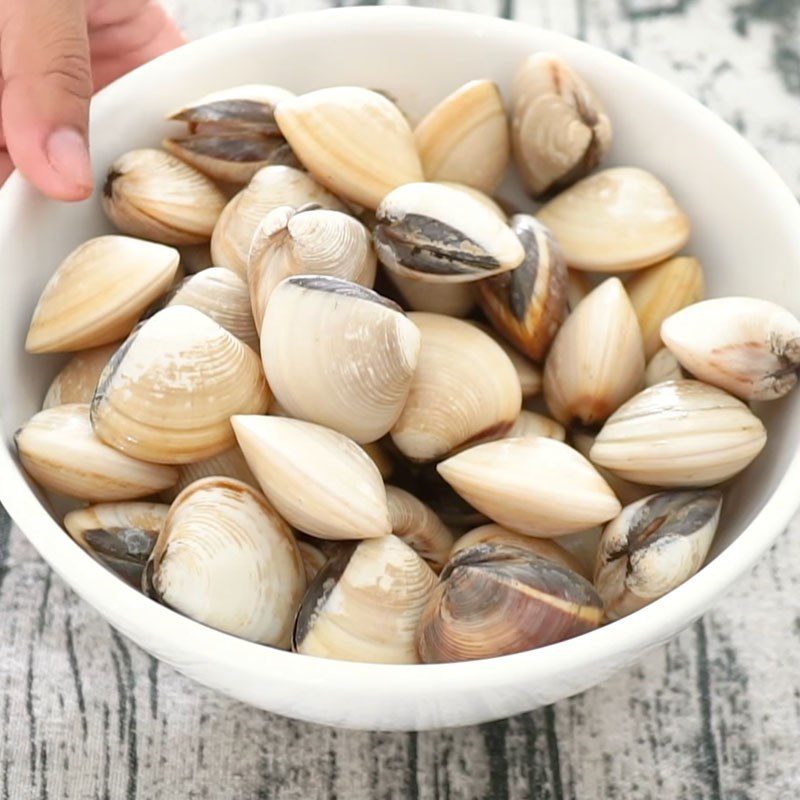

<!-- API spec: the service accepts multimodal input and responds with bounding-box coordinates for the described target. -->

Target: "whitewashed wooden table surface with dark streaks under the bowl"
[0,0,800,800]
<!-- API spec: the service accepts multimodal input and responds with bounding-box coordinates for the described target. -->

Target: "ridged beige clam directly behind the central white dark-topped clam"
[247,205,376,330]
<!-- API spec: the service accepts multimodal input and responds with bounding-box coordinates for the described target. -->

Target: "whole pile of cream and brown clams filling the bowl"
[16,53,800,663]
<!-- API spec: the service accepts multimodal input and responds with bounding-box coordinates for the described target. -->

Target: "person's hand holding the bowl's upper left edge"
[0,0,183,200]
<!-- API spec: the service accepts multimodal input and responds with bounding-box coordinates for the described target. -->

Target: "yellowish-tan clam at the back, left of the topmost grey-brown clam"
[414,80,511,194]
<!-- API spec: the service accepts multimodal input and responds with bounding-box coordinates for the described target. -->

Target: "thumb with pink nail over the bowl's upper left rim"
[0,0,93,200]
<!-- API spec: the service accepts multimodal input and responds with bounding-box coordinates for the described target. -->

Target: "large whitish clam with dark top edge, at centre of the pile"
[261,275,420,443]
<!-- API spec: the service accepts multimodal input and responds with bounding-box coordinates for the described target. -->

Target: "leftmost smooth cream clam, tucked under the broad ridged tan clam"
[14,403,178,502]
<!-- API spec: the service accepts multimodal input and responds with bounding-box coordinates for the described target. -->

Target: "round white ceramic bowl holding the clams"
[0,8,800,730]
